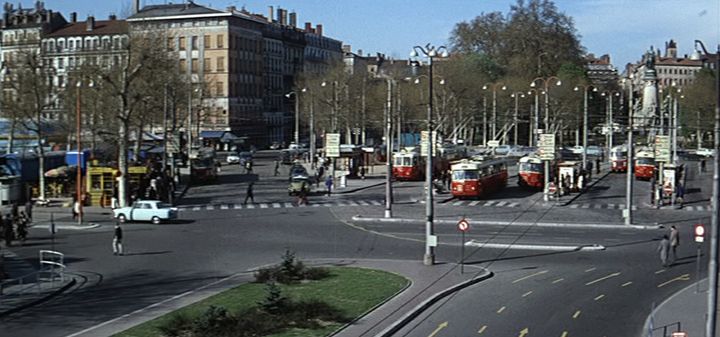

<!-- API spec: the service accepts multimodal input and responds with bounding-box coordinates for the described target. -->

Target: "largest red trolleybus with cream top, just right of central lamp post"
[451,159,508,198]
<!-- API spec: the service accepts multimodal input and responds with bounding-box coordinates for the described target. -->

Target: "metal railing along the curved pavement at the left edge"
[0,250,65,296]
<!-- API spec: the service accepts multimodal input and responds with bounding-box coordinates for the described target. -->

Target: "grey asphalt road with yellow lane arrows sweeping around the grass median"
[0,153,709,337]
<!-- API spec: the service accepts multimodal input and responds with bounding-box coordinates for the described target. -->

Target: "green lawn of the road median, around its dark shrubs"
[114,267,409,337]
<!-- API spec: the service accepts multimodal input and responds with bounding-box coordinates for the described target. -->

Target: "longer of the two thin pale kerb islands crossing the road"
[351,215,662,229]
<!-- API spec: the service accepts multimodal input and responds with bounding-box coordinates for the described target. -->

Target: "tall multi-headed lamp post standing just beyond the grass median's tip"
[410,43,449,265]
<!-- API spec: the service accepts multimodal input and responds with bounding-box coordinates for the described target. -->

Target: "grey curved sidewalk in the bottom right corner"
[641,279,717,337]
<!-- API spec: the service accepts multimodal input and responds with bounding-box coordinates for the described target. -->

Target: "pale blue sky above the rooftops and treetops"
[38,0,720,70]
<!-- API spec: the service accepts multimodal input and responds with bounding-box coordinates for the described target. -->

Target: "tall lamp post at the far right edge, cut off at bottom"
[691,40,720,337]
